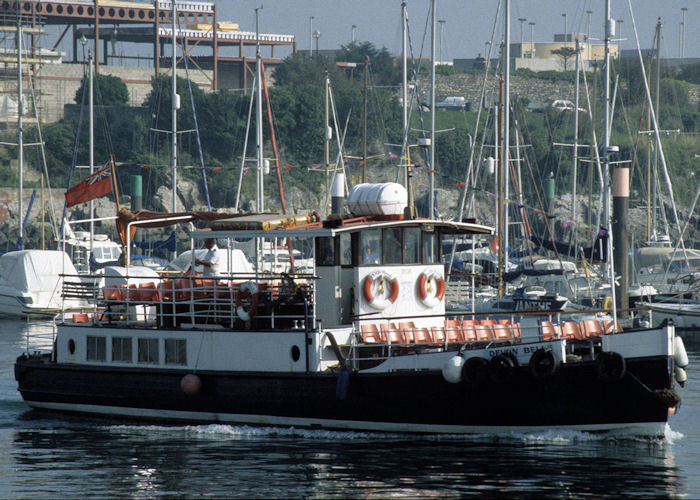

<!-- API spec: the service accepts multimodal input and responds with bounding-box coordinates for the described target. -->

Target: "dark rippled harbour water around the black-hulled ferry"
[0,320,700,498]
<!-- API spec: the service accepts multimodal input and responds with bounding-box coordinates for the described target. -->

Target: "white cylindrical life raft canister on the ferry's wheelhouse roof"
[347,182,408,215]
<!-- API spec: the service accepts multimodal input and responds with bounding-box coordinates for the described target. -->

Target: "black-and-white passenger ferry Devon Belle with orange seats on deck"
[15,186,688,436]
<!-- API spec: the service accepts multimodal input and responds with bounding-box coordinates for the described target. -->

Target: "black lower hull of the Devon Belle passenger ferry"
[15,357,672,432]
